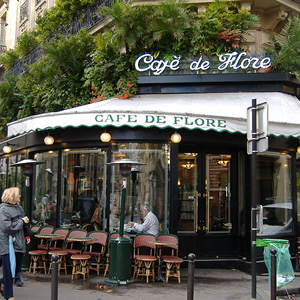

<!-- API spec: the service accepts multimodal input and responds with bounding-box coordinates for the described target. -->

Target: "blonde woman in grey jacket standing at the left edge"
[0,187,30,300]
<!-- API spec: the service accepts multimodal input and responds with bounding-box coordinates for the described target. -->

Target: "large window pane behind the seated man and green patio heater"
[110,143,170,232]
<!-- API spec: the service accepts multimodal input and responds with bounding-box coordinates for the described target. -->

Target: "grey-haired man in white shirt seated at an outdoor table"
[128,203,159,235]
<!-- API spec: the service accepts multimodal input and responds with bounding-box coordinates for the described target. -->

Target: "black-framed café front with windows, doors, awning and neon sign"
[0,53,300,269]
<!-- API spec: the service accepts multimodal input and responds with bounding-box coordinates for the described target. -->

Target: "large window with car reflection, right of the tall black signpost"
[257,152,293,235]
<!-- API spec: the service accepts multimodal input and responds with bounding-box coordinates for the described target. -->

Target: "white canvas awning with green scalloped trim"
[8,92,300,138]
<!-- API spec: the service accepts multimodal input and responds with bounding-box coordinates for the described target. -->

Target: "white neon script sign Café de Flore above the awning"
[135,51,272,75]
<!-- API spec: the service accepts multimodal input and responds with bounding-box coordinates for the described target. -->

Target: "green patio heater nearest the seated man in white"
[105,158,144,285]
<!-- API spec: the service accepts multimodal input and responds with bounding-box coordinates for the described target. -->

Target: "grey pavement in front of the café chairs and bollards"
[1,269,300,300]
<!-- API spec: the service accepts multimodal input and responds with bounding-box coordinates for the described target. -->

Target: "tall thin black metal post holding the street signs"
[251,99,257,299]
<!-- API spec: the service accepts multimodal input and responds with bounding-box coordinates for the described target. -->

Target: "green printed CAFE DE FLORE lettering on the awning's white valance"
[95,113,226,129]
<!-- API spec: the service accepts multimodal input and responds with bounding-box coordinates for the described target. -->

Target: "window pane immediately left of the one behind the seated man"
[61,149,106,229]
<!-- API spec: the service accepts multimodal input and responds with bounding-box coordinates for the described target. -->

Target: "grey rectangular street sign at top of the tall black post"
[247,102,269,155]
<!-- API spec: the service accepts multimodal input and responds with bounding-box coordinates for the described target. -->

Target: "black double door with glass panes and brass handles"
[178,152,232,256]
